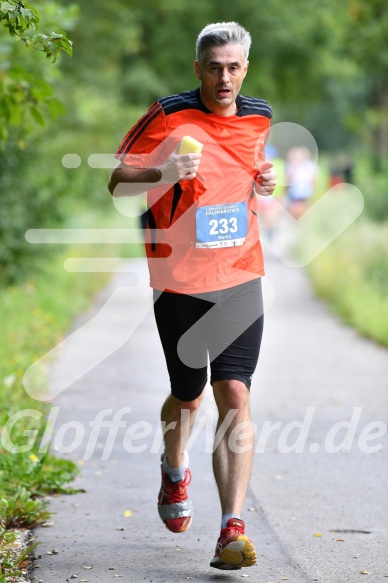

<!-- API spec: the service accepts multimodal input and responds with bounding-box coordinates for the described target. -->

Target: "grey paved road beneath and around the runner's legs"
[33,256,388,583]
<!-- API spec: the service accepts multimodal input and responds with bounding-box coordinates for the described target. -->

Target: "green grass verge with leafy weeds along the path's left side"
[0,205,141,583]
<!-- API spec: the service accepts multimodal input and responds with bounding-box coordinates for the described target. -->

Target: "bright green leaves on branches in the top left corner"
[0,0,76,148]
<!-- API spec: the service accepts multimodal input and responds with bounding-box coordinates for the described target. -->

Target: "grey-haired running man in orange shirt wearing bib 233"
[109,22,276,570]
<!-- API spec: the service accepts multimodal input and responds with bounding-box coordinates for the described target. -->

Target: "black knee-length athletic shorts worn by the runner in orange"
[154,278,264,401]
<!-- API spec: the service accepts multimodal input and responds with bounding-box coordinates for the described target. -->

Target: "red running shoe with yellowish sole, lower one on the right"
[210,518,256,570]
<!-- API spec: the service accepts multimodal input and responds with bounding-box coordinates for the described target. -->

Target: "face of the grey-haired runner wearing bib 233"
[194,44,248,115]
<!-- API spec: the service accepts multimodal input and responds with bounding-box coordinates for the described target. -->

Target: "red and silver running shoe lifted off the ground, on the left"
[158,458,193,532]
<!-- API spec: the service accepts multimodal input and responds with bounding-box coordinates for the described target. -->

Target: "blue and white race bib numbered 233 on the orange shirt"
[196,202,248,249]
